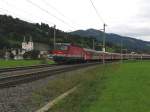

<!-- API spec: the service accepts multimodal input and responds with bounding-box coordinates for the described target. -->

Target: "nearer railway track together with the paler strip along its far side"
[0,63,101,89]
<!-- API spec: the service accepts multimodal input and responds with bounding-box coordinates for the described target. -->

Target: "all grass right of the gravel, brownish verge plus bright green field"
[27,61,150,112]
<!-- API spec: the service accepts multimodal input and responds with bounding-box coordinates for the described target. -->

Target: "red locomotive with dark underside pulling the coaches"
[51,43,84,63]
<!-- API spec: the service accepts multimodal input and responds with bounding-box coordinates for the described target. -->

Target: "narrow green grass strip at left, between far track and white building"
[0,60,52,68]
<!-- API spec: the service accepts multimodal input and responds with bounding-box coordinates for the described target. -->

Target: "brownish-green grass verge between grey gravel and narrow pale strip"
[26,67,102,110]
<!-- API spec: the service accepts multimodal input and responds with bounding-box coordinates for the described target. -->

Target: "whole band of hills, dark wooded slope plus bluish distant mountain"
[0,15,150,52]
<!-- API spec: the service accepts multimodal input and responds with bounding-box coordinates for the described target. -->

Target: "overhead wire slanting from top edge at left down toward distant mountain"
[26,0,75,29]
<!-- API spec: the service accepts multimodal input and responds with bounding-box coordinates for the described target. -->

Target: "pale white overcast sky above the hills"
[0,0,150,41]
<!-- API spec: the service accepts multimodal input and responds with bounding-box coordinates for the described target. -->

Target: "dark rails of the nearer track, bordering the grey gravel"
[0,63,101,89]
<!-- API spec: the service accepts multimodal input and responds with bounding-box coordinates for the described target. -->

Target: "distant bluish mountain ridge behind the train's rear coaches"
[71,29,150,53]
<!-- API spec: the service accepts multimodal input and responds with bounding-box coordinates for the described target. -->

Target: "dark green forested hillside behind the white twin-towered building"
[0,15,103,49]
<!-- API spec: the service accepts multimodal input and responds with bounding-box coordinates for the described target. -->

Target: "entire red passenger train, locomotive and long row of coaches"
[49,43,150,63]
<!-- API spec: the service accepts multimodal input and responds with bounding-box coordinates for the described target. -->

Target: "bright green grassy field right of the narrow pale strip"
[45,61,150,112]
